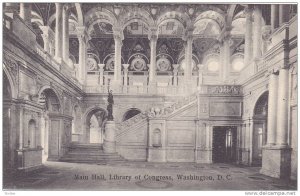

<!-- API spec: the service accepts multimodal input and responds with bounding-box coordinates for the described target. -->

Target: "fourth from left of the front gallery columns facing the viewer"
[184,29,193,89]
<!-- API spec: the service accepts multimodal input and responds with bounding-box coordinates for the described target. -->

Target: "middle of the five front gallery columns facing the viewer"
[148,29,158,85]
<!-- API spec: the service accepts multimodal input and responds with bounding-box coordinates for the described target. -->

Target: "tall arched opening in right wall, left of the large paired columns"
[252,92,269,166]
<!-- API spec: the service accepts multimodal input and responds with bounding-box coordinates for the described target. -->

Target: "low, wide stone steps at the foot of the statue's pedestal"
[60,143,125,163]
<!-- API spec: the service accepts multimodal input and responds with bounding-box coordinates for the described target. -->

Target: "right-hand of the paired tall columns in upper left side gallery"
[62,5,70,64]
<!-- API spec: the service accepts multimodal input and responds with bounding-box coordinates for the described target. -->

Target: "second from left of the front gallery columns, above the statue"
[113,29,123,87]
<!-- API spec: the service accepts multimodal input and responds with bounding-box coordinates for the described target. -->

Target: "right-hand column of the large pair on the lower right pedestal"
[276,68,289,146]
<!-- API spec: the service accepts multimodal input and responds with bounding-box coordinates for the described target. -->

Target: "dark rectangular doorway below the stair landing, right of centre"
[212,126,237,163]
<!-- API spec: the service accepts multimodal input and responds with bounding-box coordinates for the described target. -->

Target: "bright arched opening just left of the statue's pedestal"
[85,108,107,144]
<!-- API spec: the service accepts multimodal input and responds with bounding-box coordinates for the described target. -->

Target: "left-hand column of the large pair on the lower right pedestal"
[267,73,278,145]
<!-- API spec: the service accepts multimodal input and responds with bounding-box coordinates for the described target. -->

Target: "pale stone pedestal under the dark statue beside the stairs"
[103,121,116,153]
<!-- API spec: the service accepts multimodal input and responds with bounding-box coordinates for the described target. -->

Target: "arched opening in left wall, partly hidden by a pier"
[39,88,61,162]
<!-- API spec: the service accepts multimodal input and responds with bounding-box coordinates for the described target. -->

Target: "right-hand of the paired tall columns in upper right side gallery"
[253,6,262,59]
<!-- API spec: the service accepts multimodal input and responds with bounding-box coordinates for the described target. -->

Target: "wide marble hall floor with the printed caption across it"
[3,162,297,191]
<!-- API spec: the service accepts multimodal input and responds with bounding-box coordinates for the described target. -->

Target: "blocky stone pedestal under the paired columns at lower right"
[260,146,291,178]
